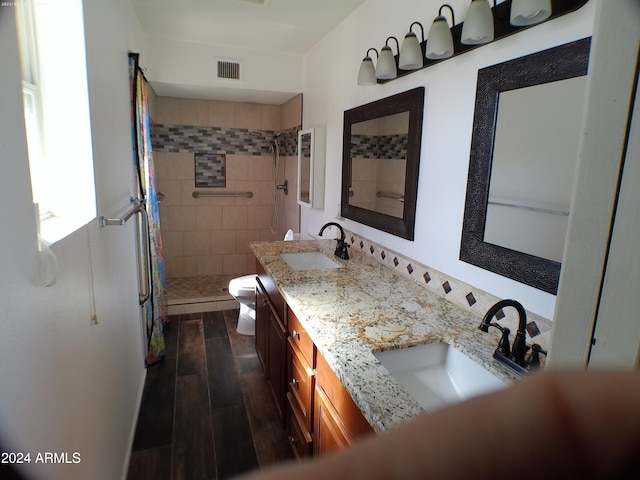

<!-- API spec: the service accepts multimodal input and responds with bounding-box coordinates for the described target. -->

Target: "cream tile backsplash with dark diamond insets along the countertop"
[345,231,552,351]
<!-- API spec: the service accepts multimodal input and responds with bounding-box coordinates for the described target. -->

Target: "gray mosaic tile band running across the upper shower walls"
[151,123,300,156]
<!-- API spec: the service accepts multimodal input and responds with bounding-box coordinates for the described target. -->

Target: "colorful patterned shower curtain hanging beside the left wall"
[129,53,167,366]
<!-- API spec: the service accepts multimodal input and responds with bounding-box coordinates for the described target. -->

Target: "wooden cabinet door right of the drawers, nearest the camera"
[313,387,351,455]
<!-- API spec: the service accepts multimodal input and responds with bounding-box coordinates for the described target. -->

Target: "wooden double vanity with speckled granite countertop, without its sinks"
[251,240,519,457]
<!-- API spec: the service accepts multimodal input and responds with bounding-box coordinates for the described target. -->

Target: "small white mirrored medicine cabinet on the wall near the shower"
[298,128,326,208]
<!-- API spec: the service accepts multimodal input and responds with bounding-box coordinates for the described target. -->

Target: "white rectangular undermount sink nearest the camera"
[374,343,507,411]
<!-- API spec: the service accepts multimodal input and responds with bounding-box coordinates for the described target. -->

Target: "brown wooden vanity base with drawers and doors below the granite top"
[255,255,374,458]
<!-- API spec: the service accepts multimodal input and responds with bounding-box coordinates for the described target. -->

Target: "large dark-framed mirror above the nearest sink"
[460,38,591,294]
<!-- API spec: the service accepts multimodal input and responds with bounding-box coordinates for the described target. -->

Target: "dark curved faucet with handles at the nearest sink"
[478,299,547,374]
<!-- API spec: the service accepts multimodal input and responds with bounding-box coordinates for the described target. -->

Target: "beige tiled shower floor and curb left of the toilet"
[166,275,238,315]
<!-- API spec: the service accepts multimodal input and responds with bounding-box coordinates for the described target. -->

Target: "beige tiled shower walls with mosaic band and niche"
[150,95,302,278]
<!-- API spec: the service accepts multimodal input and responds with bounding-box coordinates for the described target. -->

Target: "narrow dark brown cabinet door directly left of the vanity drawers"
[267,309,287,419]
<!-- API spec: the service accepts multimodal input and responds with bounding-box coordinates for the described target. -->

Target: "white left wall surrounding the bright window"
[0,0,145,480]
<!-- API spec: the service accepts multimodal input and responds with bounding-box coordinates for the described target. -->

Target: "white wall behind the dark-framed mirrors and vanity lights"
[301,0,595,318]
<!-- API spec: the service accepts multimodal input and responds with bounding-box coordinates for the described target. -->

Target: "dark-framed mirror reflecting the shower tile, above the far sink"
[341,87,424,240]
